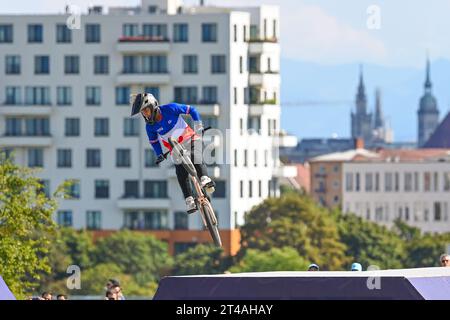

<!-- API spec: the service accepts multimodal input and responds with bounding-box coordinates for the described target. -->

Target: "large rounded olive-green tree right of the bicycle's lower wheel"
[241,193,349,270]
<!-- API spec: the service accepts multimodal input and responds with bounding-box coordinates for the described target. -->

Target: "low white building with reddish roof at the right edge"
[342,149,450,232]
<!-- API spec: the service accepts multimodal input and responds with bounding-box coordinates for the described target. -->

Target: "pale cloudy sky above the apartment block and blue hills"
[0,0,450,68]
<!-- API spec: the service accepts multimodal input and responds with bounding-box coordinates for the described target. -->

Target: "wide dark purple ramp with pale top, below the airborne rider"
[154,268,450,300]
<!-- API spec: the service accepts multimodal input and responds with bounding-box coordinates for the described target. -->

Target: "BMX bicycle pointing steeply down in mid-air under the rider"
[159,127,222,247]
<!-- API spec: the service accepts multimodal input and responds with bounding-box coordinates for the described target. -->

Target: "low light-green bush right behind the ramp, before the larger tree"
[230,247,309,272]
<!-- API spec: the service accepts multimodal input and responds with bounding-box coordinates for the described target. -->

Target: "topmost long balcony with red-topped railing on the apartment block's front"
[117,36,170,53]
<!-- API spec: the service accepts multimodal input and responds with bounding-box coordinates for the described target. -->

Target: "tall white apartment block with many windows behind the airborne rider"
[0,0,296,254]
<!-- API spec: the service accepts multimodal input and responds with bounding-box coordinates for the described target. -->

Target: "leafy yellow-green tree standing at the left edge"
[0,153,63,298]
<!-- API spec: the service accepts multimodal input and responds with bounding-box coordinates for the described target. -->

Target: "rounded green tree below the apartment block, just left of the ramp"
[93,231,172,284]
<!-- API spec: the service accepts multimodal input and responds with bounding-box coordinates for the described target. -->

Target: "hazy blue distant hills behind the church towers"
[281,59,450,141]
